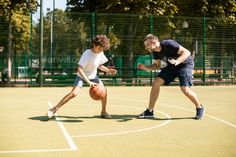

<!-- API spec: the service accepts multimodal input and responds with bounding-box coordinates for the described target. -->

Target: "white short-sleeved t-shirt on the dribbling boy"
[78,49,108,79]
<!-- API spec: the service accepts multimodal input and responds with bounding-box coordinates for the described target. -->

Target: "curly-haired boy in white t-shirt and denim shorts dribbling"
[47,35,117,119]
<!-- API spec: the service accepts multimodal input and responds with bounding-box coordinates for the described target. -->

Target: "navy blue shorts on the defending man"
[157,66,193,87]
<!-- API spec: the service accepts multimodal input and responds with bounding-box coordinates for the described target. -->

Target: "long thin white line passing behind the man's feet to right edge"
[110,97,236,128]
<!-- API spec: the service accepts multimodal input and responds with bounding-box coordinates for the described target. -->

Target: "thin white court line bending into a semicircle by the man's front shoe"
[71,105,171,138]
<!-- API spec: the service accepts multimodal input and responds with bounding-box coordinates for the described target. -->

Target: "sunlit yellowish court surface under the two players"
[0,86,236,157]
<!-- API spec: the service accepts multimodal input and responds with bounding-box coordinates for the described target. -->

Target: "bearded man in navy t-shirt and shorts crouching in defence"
[138,34,205,119]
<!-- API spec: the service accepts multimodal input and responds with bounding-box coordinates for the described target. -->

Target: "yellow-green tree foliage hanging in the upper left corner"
[0,0,38,51]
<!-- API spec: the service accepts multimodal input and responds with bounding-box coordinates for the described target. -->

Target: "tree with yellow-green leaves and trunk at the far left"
[0,0,37,86]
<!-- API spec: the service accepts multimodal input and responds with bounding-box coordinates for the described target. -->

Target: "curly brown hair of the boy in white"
[92,34,110,50]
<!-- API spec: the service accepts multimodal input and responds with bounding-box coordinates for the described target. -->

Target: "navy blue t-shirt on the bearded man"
[152,39,193,67]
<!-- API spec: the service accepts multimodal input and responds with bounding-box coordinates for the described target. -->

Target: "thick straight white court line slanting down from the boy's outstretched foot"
[48,101,78,150]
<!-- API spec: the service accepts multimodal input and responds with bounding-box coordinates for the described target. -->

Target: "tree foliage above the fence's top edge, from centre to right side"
[67,0,236,23]
